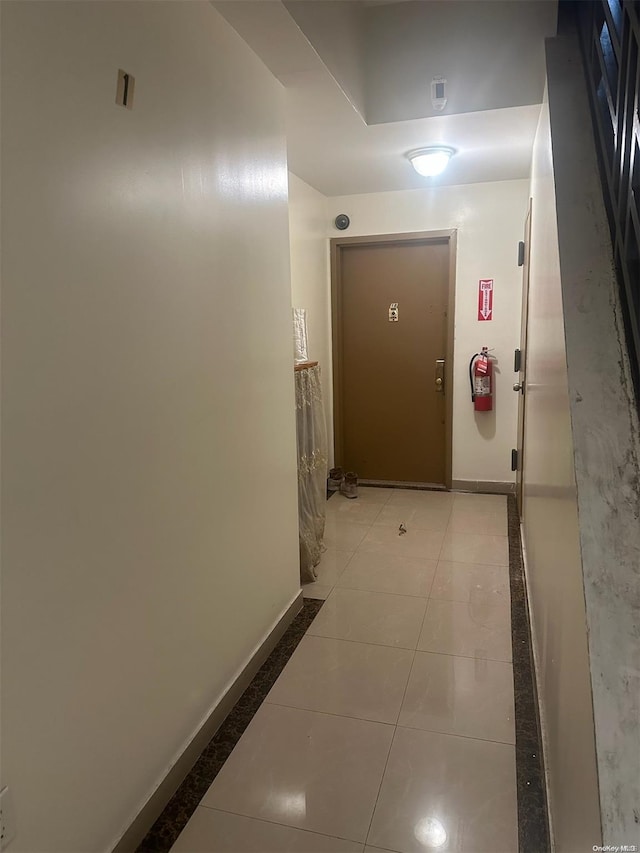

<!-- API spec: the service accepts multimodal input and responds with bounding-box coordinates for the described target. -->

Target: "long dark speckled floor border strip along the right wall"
[507,495,551,853]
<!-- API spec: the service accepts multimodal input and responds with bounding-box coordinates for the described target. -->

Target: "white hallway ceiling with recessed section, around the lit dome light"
[214,0,557,196]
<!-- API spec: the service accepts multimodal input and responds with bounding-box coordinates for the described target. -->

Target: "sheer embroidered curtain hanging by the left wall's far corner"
[295,367,327,583]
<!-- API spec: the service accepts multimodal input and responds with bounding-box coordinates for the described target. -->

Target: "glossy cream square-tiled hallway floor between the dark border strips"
[173,487,518,853]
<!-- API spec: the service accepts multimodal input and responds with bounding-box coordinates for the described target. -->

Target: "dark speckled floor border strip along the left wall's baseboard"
[138,598,324,853]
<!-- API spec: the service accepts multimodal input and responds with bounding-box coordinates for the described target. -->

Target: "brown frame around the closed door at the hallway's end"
[329,228,458,489]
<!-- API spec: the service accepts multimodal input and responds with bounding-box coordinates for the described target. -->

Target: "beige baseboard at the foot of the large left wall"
[111,590,303,853]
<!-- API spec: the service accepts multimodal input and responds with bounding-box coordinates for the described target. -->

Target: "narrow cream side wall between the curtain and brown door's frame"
[289,172,333,465]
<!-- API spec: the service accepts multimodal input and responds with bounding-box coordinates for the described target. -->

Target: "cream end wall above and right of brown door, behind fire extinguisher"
[328,181,529,483]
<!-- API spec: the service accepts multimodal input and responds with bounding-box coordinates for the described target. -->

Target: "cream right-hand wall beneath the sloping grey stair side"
[523,86,604,853]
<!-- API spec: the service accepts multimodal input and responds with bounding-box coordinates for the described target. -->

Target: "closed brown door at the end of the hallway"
[336,239,450,485]
